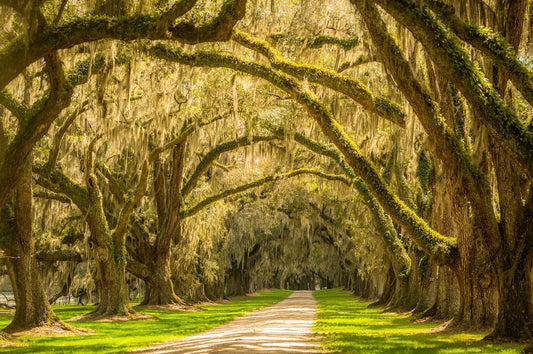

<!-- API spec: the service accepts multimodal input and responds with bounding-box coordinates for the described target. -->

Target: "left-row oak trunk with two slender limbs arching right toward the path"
[128,134,328,305]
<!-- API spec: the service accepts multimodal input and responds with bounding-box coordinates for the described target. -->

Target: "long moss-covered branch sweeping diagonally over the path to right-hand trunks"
[148,44,457,261]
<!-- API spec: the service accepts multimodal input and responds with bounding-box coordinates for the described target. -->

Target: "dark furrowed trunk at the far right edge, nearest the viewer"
[489,146,533,340]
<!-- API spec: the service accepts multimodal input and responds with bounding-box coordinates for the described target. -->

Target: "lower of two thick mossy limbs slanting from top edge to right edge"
[370,0,533,178]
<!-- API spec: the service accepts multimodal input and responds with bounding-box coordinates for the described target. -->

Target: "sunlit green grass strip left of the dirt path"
[0,290,291,353]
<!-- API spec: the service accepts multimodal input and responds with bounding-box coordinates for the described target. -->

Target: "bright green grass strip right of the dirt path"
[313,289,523,353]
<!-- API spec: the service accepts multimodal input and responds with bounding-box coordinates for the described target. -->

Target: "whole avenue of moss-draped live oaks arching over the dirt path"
[0,0,533,340]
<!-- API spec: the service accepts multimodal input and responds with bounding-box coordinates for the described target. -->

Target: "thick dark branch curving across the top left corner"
[0,0,246,88]
